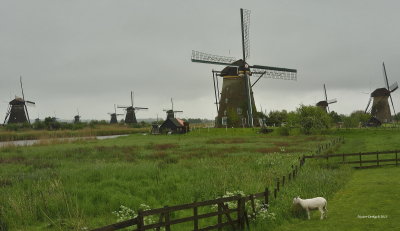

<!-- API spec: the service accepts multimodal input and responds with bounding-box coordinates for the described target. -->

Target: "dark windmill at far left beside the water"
[4,76,35,124]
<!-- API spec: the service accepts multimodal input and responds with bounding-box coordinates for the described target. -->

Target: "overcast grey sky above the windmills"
[0,0,400,123]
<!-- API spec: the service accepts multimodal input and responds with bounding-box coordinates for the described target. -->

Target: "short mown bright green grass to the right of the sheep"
[273,167,400,231]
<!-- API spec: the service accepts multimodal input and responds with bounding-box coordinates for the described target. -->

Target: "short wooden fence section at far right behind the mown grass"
[305,150,400,168]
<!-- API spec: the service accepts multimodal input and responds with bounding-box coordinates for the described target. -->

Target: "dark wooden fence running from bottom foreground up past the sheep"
[92,156,305,231]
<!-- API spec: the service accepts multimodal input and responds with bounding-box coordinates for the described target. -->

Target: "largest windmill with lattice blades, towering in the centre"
[191,9,297,127]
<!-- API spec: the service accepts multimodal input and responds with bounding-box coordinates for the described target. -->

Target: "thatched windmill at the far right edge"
[365,63,399,123]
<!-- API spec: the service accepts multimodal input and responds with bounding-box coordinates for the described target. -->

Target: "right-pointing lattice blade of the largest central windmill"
[250,65,297,80]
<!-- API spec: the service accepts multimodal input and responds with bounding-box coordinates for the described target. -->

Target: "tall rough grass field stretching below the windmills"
[0,129,400,230]
